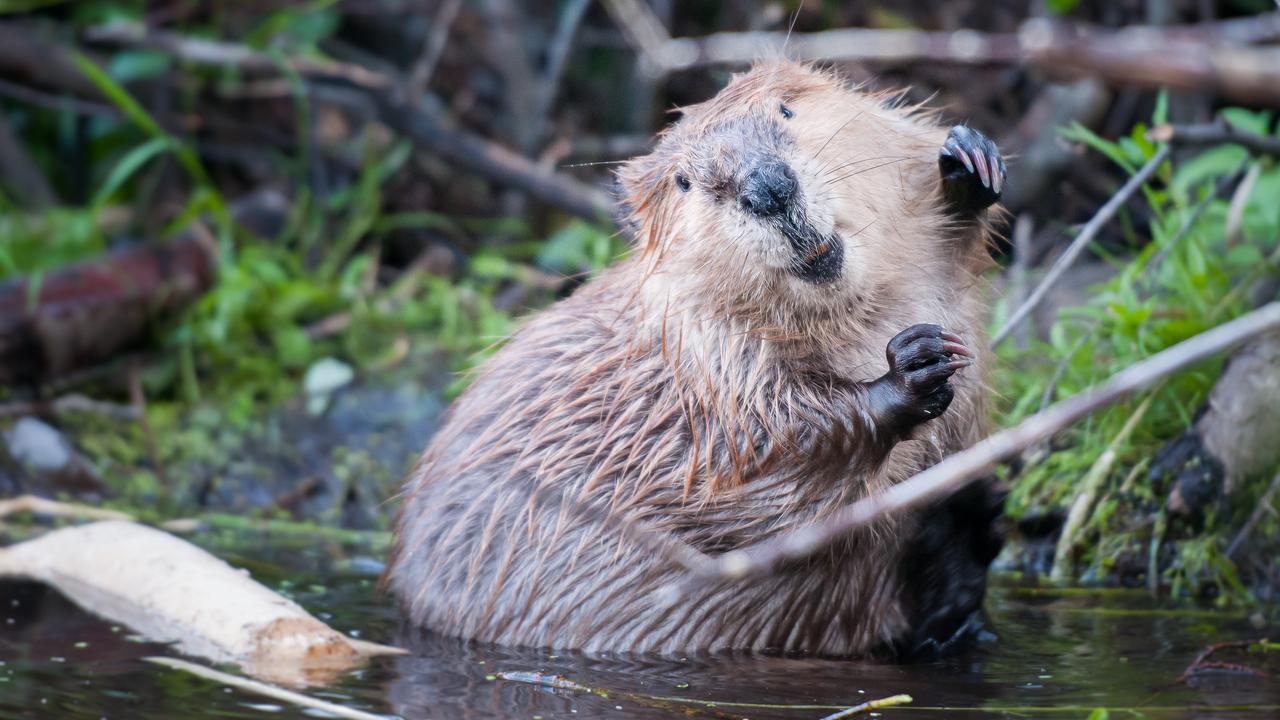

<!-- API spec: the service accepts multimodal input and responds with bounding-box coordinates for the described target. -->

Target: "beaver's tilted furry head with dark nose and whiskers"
[620,63,937,307]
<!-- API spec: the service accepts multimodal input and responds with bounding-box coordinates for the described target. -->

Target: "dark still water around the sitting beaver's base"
[0,538,1280,720]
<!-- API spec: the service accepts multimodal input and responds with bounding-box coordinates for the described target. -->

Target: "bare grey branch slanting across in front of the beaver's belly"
[676,302,1280,592]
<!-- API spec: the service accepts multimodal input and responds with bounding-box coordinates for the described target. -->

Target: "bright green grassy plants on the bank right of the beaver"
[995,101,1280,598]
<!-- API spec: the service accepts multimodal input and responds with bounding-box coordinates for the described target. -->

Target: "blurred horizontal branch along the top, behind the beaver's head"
[605,0,1280,102]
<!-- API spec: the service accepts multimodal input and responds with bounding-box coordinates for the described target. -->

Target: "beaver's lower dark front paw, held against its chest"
[876,324,973,430]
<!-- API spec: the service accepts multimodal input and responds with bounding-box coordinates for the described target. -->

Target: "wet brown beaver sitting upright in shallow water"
[387,61,1005,656]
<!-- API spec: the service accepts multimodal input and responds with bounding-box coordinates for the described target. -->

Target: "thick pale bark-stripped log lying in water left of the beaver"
[0,520,403,684]
